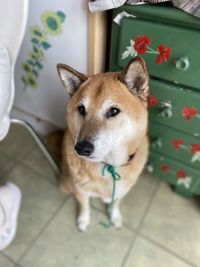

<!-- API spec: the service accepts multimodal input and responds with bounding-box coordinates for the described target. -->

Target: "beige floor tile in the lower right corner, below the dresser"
[141,182,200,266]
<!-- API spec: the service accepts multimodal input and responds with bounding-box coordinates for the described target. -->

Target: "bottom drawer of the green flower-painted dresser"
[147,152,200,195]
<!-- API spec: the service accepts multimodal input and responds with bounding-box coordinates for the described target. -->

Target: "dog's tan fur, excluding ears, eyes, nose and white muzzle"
[57,57,148,230]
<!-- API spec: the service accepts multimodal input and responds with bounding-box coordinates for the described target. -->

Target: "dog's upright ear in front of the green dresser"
[118,57,149,100]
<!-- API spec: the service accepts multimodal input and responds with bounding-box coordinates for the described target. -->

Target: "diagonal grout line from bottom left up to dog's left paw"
[18,196,71,264]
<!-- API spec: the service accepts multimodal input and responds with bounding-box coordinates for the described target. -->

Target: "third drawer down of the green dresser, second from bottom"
[149,122,200,169]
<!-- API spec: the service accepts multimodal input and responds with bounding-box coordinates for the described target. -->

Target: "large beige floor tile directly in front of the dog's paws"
[21,198,134,267]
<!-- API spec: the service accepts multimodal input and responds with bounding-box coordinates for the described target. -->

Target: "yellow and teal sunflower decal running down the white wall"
[21,11,65,89]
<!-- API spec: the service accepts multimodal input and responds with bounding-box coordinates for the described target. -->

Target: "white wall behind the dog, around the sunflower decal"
[12,0,88,134]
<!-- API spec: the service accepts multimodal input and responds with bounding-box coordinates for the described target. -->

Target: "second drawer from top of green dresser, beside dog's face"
[149,79,200,137]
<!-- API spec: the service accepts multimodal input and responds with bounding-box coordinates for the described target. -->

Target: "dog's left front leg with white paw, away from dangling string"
[75,192,90,231]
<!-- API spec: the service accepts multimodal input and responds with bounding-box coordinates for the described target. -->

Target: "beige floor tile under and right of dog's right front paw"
[92,173,159,229]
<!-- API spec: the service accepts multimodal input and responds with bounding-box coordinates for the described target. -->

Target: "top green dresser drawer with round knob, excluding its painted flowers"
[116,18,200,90]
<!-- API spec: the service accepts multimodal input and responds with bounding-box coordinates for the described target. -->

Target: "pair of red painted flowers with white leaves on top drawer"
[122,35,171,64]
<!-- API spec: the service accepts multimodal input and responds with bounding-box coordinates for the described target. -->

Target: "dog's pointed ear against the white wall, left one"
[57,64,87,96]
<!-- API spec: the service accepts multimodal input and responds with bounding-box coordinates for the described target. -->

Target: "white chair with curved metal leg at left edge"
[0,0,59,173]
